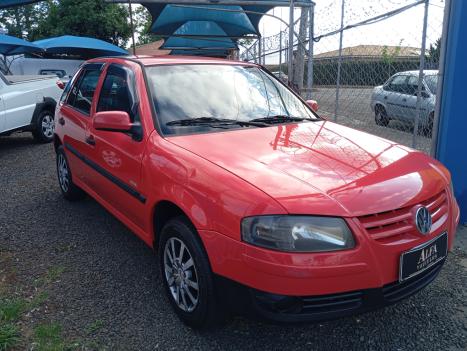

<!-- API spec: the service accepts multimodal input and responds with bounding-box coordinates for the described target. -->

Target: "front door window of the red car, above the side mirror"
[97,65,139,122]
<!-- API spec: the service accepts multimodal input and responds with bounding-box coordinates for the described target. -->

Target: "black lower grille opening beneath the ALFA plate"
[383,261,444,303]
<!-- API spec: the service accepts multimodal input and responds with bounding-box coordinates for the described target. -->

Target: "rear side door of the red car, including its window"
[57,63,103,185]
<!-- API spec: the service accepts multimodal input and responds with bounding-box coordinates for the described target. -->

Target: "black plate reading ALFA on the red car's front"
[399,232,448,282]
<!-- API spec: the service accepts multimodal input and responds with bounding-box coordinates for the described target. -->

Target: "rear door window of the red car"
[67,68,101,115]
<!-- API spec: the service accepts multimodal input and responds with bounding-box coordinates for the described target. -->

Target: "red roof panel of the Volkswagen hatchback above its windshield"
[91,55,254,66]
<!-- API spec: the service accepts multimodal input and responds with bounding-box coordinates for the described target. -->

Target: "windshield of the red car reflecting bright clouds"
[147,64,316,134]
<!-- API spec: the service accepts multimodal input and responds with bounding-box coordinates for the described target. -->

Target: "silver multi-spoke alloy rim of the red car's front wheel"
[164,237,199,312]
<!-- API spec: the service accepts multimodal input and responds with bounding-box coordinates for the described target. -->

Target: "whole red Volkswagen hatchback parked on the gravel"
[55,56,459,327]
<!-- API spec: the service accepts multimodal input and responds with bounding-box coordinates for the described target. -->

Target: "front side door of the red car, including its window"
[89,64,146,234]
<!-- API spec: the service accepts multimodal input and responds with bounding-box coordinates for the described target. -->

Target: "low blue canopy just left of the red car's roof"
[34,35,128,57]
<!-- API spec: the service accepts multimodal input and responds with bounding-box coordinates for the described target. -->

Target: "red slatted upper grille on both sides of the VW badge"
[358,190,448,241]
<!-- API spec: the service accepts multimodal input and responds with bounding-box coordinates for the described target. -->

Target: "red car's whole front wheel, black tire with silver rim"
[158,217,222,329]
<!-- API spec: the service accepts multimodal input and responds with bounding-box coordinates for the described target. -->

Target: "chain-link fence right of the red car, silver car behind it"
[241,0,444,153]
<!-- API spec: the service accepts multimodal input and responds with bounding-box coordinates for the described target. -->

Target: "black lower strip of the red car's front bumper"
[250,261,444,322]
